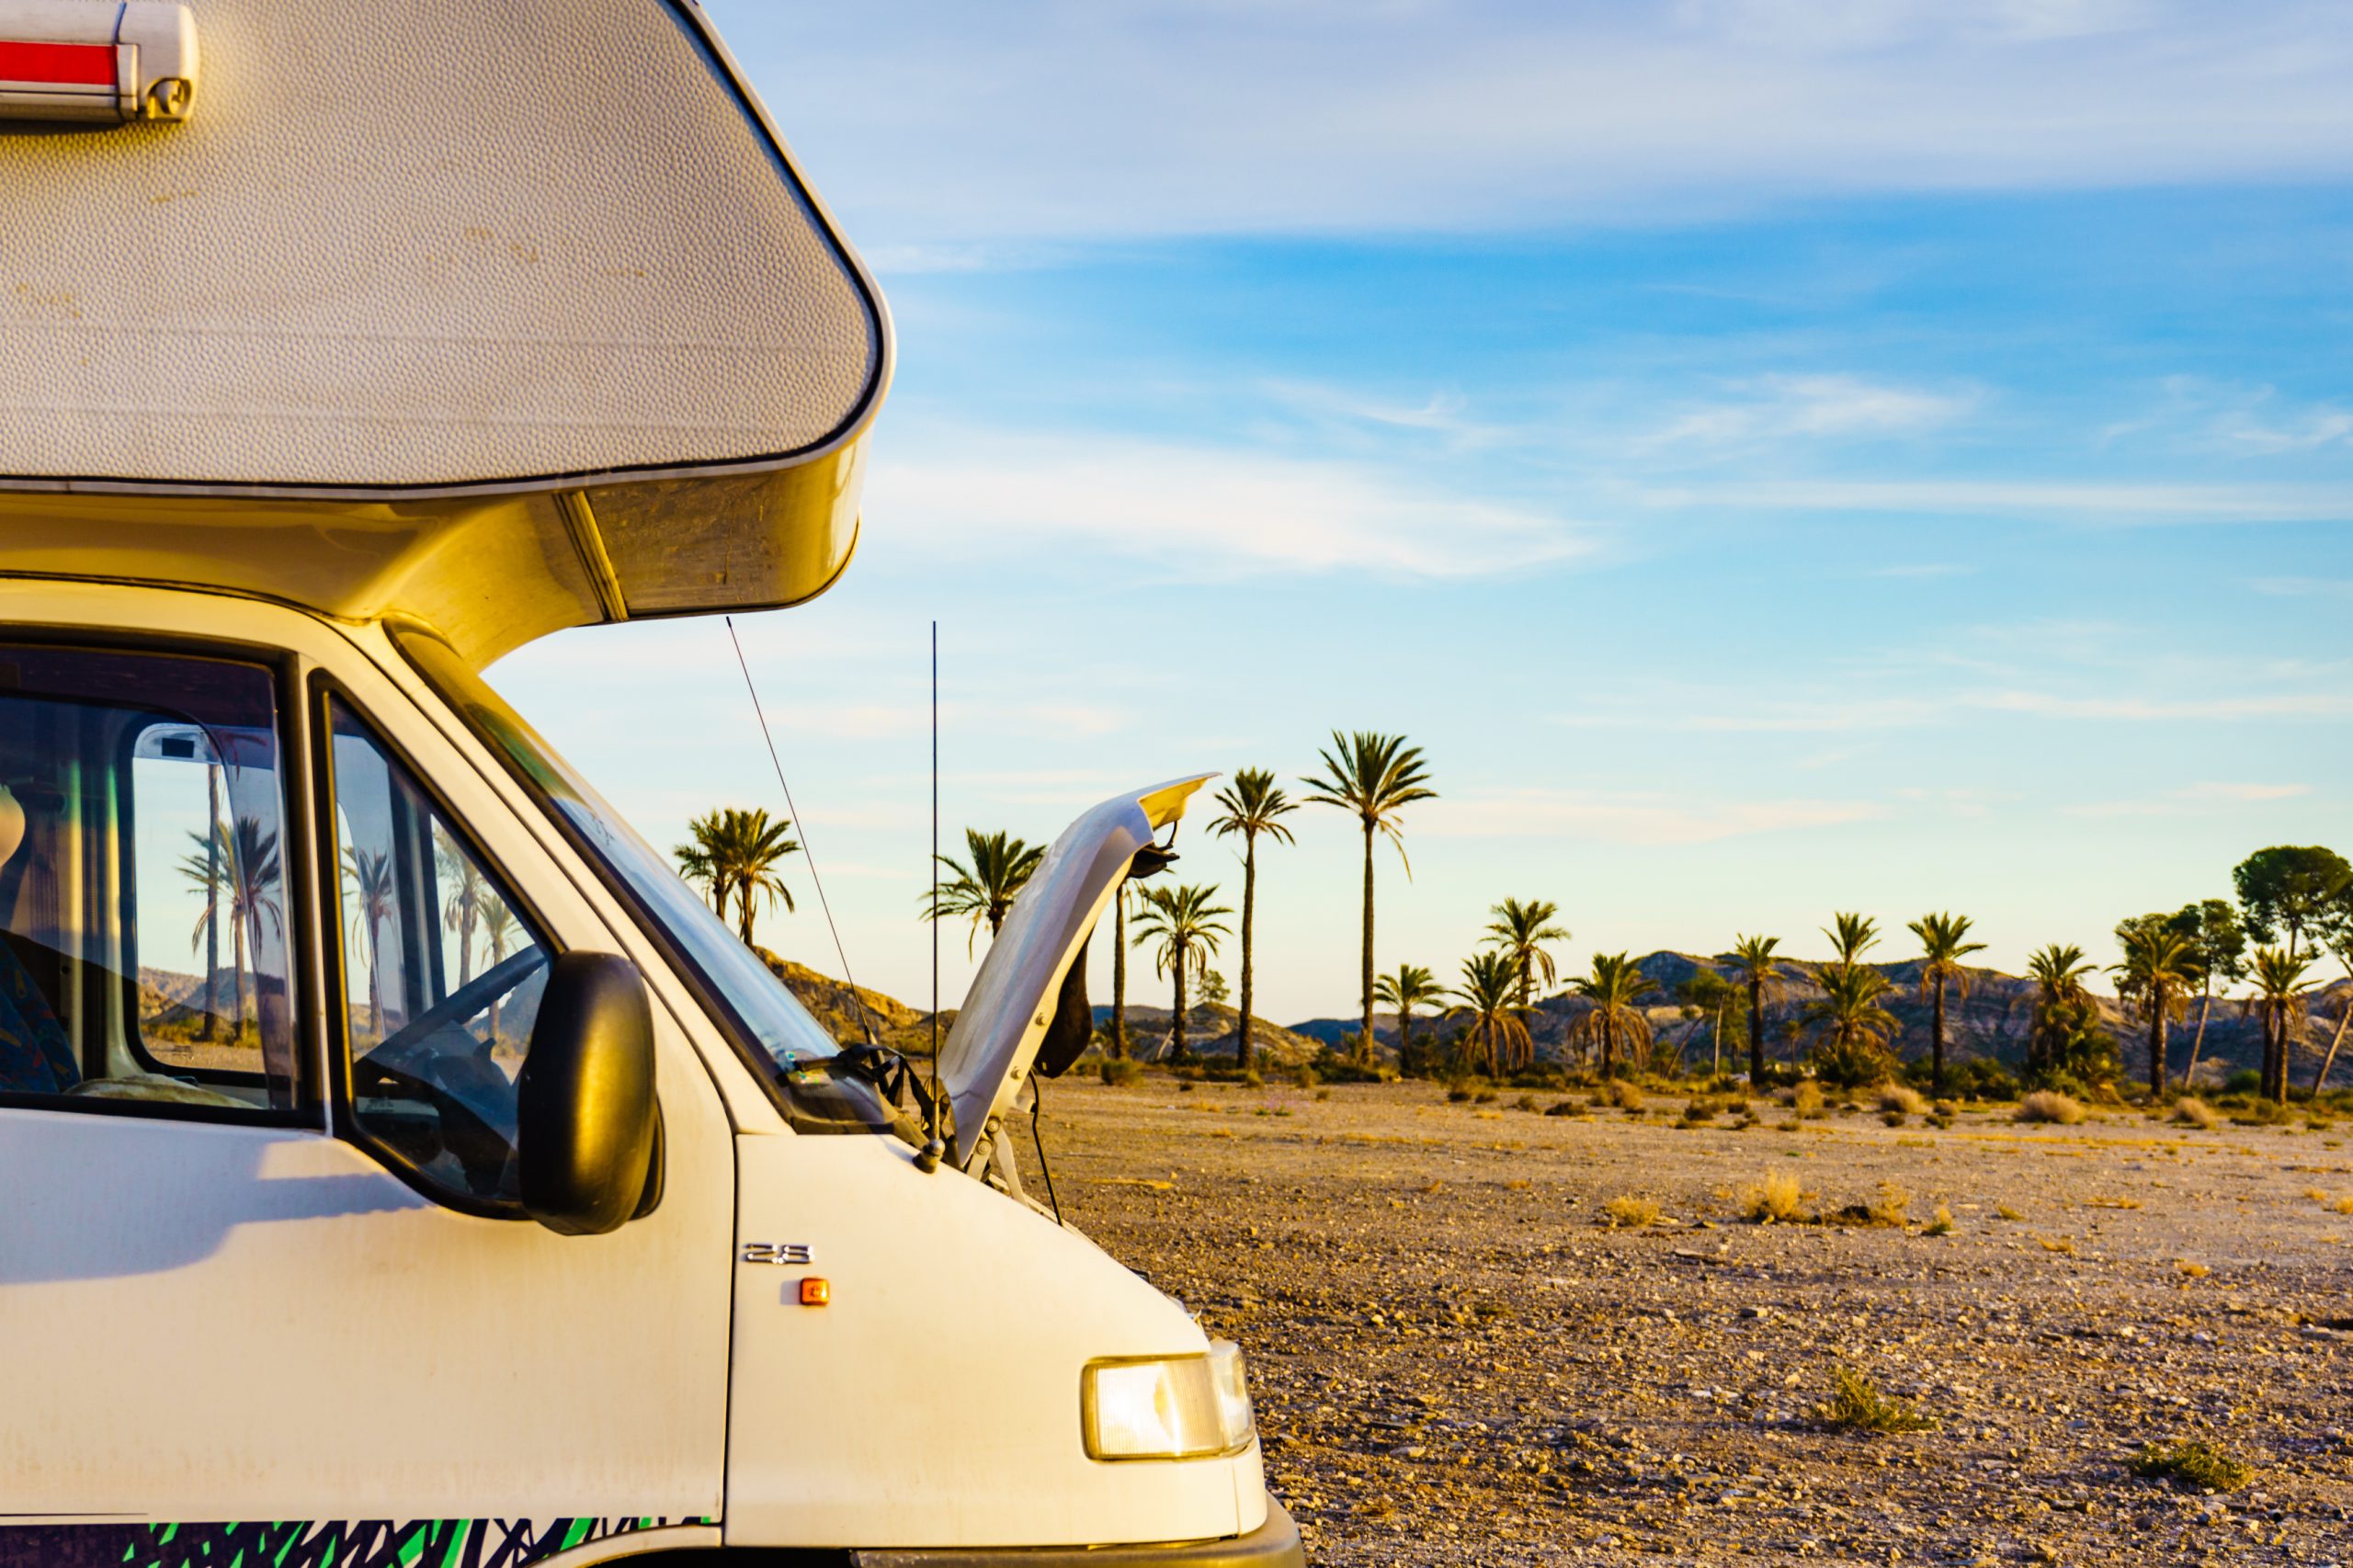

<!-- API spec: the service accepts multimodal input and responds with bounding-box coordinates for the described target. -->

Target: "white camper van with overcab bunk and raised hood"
[0,0,1302,1568]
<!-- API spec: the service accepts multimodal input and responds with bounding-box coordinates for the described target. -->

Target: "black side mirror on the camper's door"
[516,953,661,1236]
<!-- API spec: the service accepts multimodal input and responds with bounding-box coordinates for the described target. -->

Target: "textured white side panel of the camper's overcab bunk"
[0,0,887,494]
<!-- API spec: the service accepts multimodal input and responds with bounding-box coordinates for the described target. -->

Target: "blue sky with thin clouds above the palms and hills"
[492,0,2353,1019]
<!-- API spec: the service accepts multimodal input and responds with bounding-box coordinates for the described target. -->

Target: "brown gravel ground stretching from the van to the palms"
[1026,1076,2353,1568]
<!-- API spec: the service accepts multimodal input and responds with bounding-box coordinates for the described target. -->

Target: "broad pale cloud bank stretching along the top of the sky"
[710,0,2353,244]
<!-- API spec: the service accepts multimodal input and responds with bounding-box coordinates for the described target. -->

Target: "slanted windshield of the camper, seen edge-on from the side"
[398,633,894,1128]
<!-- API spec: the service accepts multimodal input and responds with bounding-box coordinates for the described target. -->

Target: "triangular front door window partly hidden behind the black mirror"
[327,697,548,1208]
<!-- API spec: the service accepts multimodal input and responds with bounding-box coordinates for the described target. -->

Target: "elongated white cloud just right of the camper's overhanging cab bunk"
[869,433,1593,577]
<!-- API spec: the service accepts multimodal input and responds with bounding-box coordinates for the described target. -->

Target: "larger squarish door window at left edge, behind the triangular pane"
[0,645,301,1119]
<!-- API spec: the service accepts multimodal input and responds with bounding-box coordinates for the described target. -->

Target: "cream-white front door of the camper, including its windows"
[0,631,732,1563]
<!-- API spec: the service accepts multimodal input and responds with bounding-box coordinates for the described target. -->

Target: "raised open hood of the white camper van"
[938,772,1217,1168]
